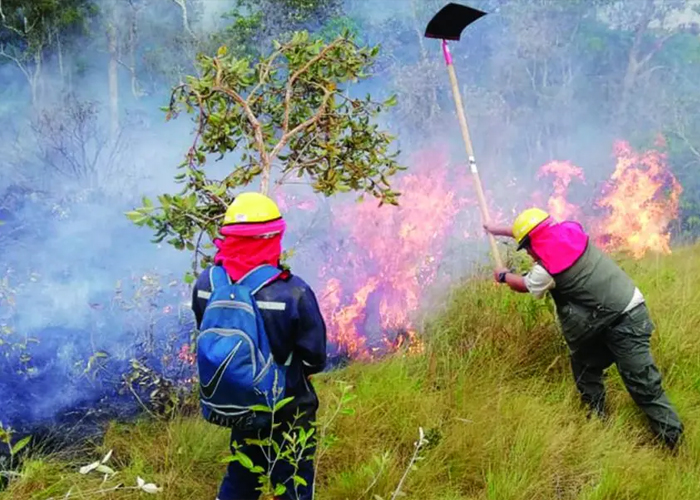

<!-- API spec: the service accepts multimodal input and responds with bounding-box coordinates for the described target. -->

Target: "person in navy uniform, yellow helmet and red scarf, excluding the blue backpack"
[192,192,326,500]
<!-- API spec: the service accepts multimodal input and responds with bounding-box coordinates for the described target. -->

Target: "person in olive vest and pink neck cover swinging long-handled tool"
[484,208,683,449]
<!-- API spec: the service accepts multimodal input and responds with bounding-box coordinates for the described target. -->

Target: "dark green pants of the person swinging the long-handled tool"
[571,304,683,448]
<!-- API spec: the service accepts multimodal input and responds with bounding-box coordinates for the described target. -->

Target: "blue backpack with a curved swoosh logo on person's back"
[197,265,291,429]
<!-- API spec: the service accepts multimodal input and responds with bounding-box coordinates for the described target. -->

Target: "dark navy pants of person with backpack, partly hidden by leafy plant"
[217,414,315,500]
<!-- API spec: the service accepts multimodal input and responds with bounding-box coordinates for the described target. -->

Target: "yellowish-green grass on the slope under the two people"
[0,247,700,500]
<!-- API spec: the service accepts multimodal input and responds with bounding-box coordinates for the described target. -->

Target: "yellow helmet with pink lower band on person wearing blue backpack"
[221,192,285,236]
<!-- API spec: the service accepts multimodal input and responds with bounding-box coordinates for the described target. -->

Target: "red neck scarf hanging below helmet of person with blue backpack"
[214,233,282,281]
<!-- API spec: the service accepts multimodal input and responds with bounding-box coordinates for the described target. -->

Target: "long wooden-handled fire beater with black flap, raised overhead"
[425,3,503,268]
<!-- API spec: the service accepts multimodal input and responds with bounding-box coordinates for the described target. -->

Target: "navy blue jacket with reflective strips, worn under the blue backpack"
[192,268,326,420]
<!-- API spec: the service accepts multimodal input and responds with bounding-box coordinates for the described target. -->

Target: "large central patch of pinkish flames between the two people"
[321,152,467,358]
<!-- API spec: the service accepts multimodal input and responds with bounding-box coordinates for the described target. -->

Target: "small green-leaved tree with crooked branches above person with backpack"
[127,32,403,276]
